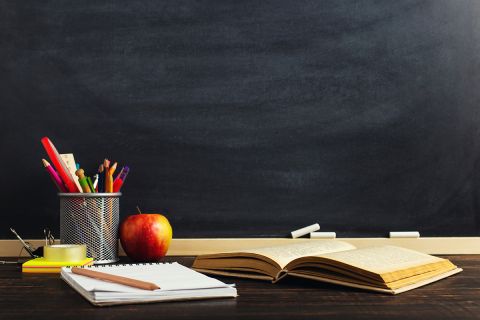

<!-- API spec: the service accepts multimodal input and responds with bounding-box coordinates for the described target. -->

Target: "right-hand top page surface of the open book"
[319,246,445,274]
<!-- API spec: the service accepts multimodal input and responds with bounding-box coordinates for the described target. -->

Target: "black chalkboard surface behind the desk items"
[0,0,480,238]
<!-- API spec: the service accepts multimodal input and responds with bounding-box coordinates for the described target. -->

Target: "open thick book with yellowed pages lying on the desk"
[192,240,462,294]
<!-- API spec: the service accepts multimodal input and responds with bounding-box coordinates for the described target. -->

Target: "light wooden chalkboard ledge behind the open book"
[0,237,480,257]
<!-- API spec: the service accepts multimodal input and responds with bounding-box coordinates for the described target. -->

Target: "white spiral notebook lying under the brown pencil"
[60,262,237,306]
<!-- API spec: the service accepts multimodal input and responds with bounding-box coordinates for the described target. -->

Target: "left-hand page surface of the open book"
[243,240,355,269]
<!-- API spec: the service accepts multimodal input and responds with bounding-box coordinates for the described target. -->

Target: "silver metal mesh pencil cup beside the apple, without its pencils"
[58,192,122,264]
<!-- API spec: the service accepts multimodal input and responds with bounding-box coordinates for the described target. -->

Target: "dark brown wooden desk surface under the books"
[0,255,480,320]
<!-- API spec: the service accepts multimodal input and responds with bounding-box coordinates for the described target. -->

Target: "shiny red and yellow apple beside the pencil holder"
[120,213,172,261]
